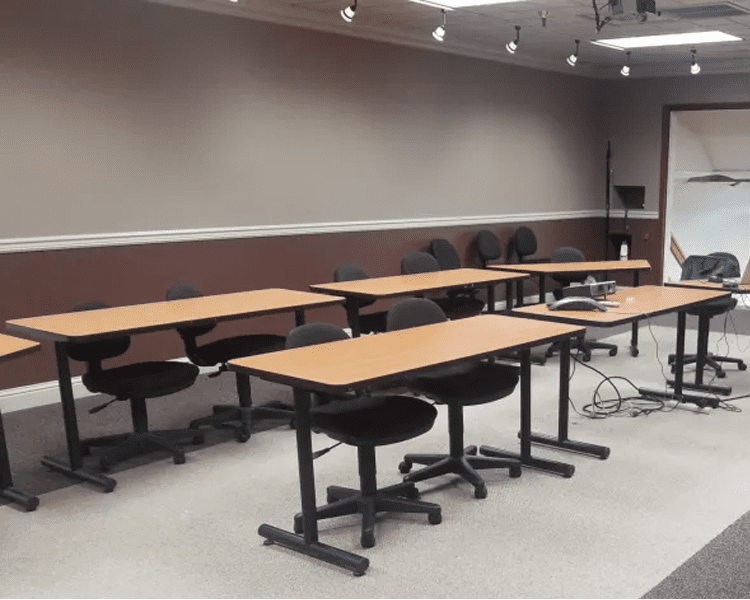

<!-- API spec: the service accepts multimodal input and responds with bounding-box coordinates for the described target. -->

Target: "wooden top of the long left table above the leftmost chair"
[6,288,344,342]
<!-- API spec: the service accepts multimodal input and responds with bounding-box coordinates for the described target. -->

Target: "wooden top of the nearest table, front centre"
[229,314,583,392]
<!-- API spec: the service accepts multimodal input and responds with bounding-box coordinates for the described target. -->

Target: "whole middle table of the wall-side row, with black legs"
[310,269,528,337]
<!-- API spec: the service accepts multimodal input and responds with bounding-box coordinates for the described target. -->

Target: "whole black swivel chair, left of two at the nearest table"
[286,323,442,548]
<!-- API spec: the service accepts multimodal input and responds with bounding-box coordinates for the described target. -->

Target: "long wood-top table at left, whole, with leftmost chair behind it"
[7,288,343,492]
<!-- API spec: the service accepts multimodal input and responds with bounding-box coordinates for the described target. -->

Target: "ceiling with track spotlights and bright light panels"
[151,0,750,78]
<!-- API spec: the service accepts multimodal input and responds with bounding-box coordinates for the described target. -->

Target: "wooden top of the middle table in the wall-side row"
[310,269,528,298]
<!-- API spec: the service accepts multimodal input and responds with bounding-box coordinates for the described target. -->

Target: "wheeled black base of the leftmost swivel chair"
[81,429,203,472]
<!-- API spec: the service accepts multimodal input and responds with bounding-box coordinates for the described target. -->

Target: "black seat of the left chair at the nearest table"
[310,395,437,446]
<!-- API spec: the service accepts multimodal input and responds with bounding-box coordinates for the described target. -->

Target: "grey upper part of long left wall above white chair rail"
[0,0,606,240]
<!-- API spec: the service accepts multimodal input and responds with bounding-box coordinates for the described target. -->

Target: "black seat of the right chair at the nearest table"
[408,362,519,406]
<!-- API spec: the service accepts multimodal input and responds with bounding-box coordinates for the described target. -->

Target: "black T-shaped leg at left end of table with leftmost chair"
[42,342,117,492]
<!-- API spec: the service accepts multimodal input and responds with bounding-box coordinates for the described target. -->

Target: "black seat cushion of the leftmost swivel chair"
[82,361,200,400]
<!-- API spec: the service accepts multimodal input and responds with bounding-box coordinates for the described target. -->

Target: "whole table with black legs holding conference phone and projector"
[513,285,729,412]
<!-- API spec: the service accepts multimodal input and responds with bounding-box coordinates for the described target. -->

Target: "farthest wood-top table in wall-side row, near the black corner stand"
[488,259,651,356]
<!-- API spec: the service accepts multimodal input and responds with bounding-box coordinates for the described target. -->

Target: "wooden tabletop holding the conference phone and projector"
[513,285,729,327]
